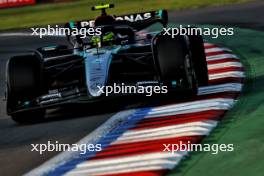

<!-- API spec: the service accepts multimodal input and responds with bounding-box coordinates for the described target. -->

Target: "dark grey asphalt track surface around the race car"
[0,2,264,175]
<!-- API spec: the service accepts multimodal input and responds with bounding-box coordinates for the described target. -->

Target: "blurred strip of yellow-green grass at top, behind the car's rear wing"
[0,0,252,30]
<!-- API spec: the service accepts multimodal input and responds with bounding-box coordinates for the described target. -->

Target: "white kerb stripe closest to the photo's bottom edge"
[66,152,187,176]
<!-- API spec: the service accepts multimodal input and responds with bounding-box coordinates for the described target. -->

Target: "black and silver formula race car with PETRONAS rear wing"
[6,4,208,123]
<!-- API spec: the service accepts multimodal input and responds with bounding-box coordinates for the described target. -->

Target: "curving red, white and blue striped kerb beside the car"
[27,43,245,176]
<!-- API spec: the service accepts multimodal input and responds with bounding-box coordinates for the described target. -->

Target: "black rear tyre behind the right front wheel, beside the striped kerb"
[188,35,208,86]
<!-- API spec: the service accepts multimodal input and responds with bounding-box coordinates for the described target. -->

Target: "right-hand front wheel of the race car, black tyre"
[155,35,197,95]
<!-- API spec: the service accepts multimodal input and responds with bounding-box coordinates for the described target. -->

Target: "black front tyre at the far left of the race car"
[7,55,45,123]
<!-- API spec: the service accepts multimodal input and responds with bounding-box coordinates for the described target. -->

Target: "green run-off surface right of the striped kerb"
[169,26,264,176]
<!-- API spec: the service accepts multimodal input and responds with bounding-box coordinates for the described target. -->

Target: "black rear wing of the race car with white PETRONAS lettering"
[66,10,168,30]
